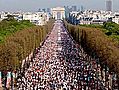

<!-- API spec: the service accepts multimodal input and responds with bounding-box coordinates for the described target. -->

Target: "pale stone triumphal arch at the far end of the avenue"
[51,7,65,20]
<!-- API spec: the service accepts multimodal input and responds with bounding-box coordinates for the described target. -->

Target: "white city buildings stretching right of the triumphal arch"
[68,10,115,25]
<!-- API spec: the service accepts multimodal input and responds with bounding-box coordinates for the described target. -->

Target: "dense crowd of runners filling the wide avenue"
[17,20,118,90]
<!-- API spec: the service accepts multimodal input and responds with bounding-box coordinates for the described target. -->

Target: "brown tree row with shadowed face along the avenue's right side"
[65,22,119,75]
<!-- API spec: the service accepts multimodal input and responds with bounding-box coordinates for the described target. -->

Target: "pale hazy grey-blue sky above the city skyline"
[0,0,119,11]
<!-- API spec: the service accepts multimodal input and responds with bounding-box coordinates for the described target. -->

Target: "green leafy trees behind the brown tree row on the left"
[0,18,35,43]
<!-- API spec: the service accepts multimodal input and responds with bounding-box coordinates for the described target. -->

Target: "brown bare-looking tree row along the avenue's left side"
[0,20,54,71]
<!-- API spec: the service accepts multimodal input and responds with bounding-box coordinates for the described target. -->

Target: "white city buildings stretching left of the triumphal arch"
[0,12,50,25]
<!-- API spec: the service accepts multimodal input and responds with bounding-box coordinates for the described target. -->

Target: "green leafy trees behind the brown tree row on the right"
[81,22,119,46]
